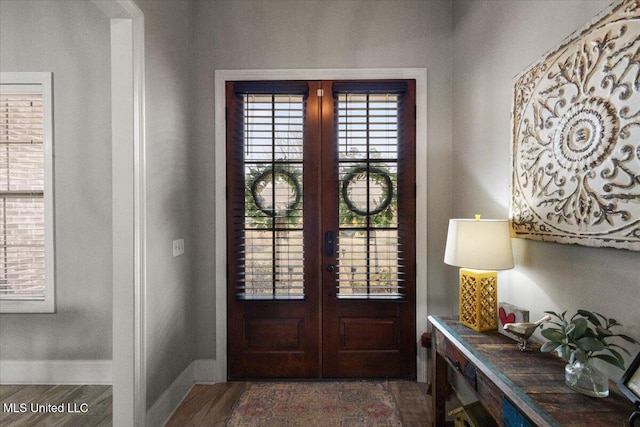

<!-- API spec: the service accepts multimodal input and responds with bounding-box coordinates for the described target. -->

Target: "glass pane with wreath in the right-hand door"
[336,93,404,299]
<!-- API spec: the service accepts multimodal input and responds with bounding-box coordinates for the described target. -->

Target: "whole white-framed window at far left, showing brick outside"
[0,73,55,313]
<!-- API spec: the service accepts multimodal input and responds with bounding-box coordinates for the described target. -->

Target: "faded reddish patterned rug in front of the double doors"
[226,381,402,427]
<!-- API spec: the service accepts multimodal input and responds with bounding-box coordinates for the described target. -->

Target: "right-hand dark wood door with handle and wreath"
[322,81,416,378]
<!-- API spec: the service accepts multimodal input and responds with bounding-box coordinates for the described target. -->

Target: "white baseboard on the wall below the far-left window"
[0,360,113,384]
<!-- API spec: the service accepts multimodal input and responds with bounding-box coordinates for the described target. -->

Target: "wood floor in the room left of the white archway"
[0,385,112,427]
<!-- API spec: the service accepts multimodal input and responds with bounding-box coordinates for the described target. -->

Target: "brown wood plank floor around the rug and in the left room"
[0,381,460,427]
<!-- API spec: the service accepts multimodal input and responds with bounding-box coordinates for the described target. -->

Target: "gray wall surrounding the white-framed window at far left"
[0,1,112,360]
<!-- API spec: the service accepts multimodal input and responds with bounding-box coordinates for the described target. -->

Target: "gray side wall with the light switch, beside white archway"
[132,0,198,408]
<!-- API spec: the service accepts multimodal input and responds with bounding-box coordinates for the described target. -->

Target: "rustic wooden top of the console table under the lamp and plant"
[429,316,634,427]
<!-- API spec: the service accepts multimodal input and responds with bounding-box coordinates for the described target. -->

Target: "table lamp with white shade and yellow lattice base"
[444,215,513,331]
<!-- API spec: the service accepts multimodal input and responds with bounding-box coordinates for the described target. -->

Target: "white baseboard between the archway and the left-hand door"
[146,359,221,427]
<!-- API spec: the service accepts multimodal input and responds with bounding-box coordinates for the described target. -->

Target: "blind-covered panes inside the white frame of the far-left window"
[0,92,45,301]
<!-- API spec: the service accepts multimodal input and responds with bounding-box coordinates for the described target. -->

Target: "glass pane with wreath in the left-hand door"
[238,94,304,299]
